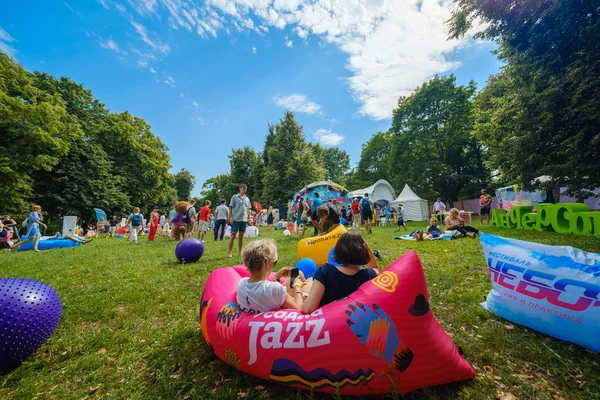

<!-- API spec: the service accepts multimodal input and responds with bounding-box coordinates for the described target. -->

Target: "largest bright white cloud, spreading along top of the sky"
[110,0,470,119]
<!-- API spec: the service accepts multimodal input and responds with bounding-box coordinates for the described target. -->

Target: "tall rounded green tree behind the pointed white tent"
[390,75,488,201]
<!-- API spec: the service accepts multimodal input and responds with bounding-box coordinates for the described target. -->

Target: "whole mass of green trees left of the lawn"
[0,53,177,222]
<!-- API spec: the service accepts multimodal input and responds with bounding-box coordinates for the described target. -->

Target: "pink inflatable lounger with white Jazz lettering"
[200,251,475,395]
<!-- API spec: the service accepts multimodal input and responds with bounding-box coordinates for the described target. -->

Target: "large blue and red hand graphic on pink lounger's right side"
[346,301,414,372]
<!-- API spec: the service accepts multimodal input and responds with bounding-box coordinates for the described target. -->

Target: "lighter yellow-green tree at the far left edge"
[0,52,82,213]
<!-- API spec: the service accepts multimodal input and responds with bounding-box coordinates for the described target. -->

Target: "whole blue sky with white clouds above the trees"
[0,0,501,195]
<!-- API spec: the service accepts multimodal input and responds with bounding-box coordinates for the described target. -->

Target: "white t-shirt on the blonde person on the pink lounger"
[237,278,287,314]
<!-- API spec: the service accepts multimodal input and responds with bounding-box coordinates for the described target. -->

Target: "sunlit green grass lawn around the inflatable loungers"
[0,223,600,399]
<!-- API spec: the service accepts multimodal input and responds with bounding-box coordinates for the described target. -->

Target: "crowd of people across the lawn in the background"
[0,184,492,257]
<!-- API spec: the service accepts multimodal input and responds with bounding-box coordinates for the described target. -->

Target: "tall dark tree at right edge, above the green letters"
[450,0,600,197]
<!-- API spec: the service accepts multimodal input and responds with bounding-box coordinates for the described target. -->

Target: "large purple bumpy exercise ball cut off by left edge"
[0,278,62,371]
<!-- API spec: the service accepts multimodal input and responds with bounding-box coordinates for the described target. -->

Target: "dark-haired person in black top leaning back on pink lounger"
[301,232,379,314]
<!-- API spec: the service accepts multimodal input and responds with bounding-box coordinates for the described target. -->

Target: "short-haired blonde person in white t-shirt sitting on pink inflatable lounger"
[237,239,312,314]
